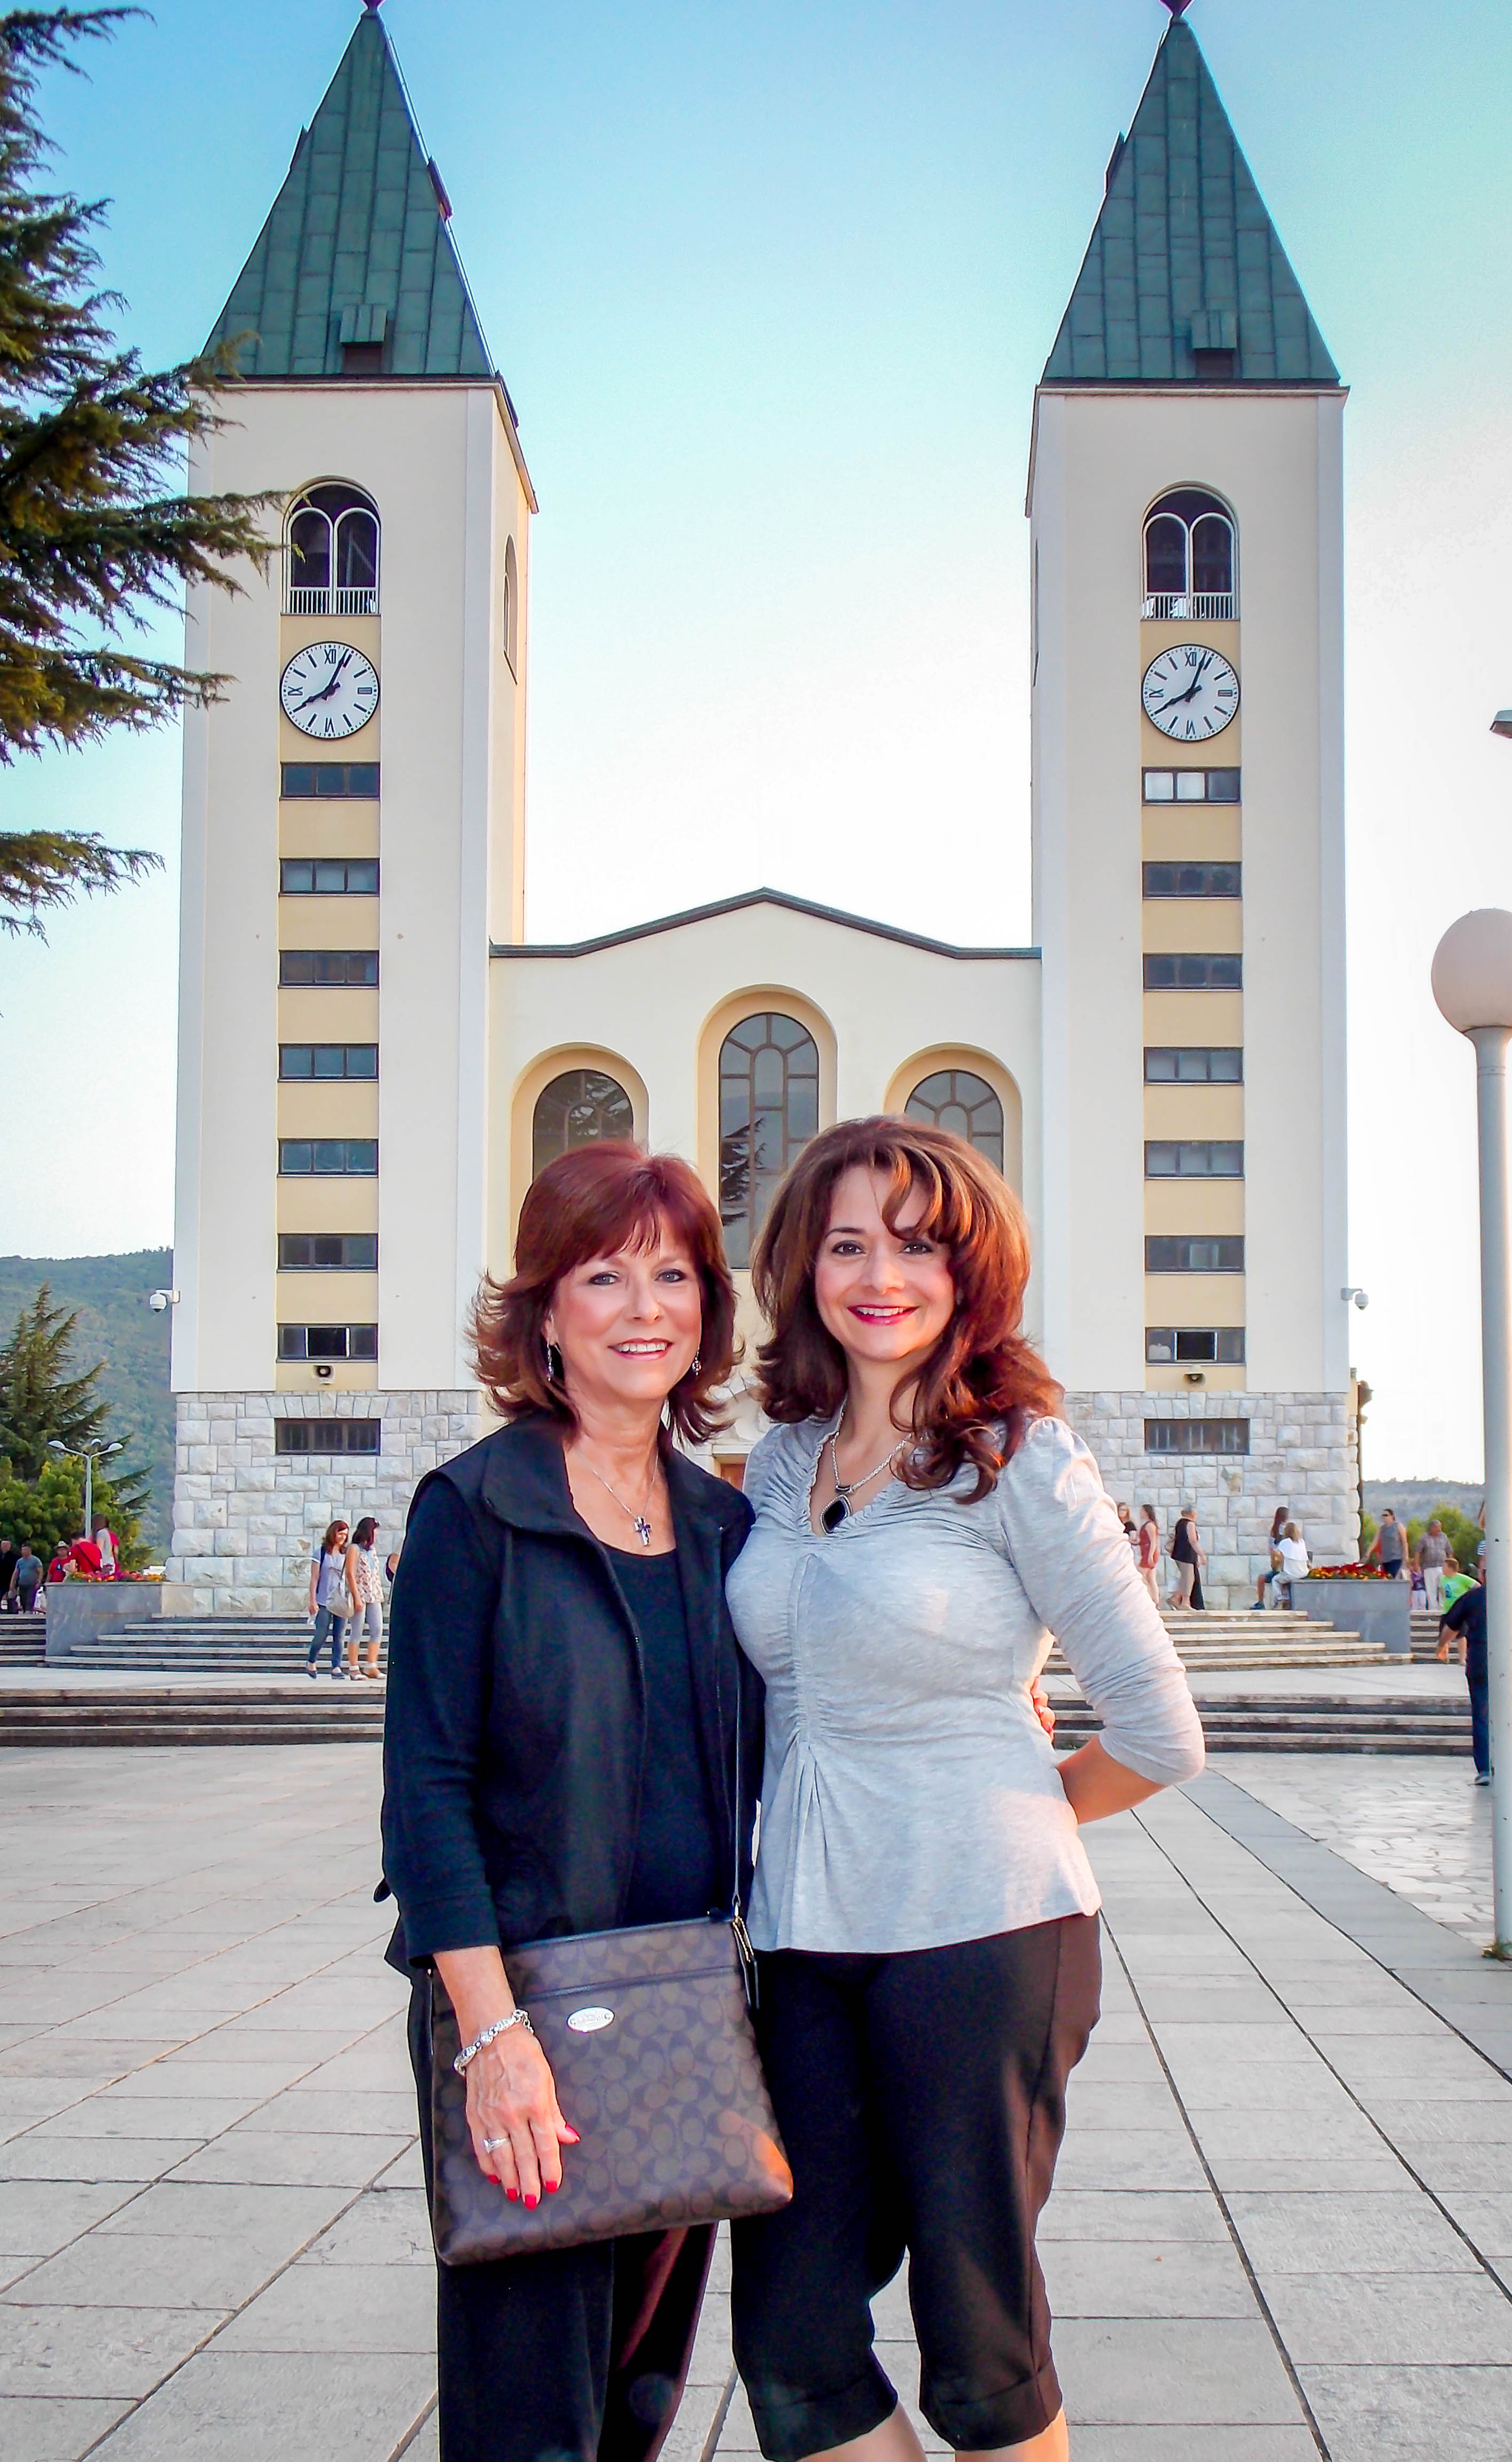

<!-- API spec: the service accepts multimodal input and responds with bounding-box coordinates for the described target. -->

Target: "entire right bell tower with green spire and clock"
[1027,0,1357,1605]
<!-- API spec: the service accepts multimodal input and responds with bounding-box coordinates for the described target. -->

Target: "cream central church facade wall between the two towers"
[490,906,1039,1339]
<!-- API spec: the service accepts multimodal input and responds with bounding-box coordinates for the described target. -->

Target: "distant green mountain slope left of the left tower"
[0,1248,173,1554]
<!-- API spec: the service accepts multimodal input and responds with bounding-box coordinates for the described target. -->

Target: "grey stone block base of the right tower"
[1066,1394,1359,1607]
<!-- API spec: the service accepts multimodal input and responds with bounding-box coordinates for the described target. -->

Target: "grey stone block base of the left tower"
[162,1388,493,1615]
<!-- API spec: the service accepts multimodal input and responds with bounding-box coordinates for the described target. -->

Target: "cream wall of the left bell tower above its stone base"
[173,384,532,1391]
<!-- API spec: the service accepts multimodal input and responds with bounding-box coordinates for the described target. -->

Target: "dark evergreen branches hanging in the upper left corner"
[0,7,271,930]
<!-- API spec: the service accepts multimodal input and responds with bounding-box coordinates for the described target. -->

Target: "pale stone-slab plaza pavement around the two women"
[0,1745,1512,2462]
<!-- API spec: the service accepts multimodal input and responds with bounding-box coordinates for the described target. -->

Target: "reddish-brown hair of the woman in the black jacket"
[468,1137,736,1445]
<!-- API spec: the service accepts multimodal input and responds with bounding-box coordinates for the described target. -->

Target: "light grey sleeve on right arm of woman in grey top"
[997,1418,1206,1788]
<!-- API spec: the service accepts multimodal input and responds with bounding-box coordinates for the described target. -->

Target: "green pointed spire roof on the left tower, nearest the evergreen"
[209,7,493,377]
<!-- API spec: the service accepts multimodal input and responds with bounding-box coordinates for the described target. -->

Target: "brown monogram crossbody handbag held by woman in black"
[431,1913,793,2265]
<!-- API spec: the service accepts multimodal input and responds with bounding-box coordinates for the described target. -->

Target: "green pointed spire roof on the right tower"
[1042,17,1339,384]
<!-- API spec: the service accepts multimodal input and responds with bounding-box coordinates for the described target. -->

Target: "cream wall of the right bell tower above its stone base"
[1030,386,1347,1391]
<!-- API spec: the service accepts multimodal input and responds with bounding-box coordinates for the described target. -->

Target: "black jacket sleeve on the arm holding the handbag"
[384,1480,500,1962]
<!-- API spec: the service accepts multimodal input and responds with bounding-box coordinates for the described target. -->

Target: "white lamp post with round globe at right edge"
[1433,906,1512,1958]
